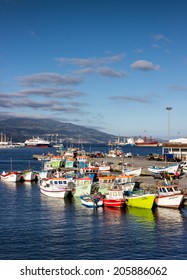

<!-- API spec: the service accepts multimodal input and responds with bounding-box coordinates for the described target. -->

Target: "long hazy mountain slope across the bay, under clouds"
[0,118,116,144]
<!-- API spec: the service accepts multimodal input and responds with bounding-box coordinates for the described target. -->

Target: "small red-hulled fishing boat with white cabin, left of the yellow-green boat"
[103,189,126,208]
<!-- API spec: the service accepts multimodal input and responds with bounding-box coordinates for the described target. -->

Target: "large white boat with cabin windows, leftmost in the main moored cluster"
[40,178,75,198]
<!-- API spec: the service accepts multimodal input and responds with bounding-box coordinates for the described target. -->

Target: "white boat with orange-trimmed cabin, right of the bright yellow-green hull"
[155,185,184,208]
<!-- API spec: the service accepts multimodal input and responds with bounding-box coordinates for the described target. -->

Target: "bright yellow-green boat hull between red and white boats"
[125,193,155,209]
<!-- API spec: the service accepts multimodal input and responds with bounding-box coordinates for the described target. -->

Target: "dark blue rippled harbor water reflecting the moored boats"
[0,147,187,260]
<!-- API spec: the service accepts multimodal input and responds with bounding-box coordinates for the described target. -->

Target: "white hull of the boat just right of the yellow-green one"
[155,194,184,208]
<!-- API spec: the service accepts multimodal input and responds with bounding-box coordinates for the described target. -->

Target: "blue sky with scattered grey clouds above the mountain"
[0,0,187,139]
